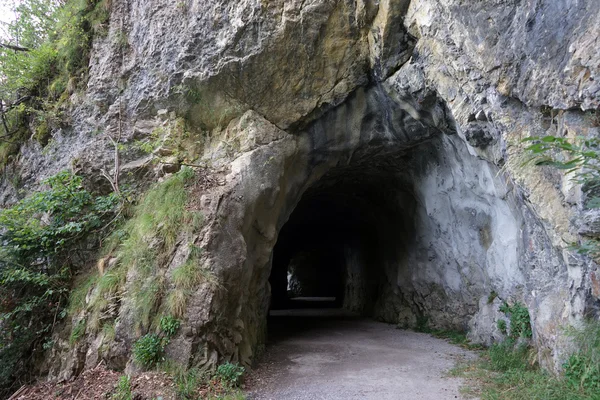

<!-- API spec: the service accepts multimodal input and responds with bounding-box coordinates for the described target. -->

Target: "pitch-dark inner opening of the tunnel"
[269,158,415,317]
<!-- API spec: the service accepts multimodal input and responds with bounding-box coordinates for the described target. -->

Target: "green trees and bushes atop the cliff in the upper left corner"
[0,0,110,166]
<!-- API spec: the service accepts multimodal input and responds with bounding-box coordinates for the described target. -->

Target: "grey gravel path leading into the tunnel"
[248,309,475,400]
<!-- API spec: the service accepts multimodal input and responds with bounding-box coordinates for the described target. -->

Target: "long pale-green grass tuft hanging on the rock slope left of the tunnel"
[90,168,194,333]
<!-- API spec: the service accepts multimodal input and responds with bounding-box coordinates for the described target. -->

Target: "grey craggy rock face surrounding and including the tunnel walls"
[2,0,600,377]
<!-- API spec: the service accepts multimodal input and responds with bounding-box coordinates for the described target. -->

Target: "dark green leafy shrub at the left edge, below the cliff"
[0,172,119,394]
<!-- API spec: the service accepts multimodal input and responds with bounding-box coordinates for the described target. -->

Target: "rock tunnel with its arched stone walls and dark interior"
[211,80,522,363]
